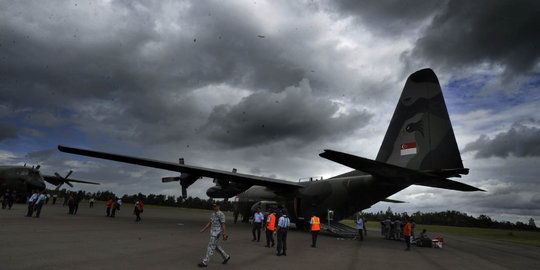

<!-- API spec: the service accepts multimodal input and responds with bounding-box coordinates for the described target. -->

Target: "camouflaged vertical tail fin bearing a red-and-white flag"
[376,69,463,171]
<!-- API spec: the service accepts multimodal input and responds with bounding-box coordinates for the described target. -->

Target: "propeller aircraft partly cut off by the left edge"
[0,164,99,197]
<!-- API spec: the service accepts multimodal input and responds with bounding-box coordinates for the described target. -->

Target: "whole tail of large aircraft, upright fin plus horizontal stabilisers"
[320,69,483,191]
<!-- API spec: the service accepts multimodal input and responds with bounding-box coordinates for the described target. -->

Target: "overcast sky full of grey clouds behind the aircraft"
[0,0,540,222]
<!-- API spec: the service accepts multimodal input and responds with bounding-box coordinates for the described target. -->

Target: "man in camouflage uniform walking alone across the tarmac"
[198,203,231,267]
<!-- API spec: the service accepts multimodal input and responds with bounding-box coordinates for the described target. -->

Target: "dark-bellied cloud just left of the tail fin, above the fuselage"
[203,80,372,147]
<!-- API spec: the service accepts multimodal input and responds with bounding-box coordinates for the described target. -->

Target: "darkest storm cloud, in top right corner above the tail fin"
[331,0,540,81]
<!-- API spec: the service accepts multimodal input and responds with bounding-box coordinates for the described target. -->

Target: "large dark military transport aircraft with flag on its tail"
[58,69,483,223]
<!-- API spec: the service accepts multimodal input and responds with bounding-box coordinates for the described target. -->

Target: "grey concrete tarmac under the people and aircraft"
[0,202,540,270]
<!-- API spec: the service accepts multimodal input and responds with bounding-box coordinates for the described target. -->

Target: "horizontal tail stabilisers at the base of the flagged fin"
[319,150,484,191]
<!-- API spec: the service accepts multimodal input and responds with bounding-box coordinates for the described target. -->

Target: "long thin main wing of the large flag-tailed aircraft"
[58,145,303,188]
